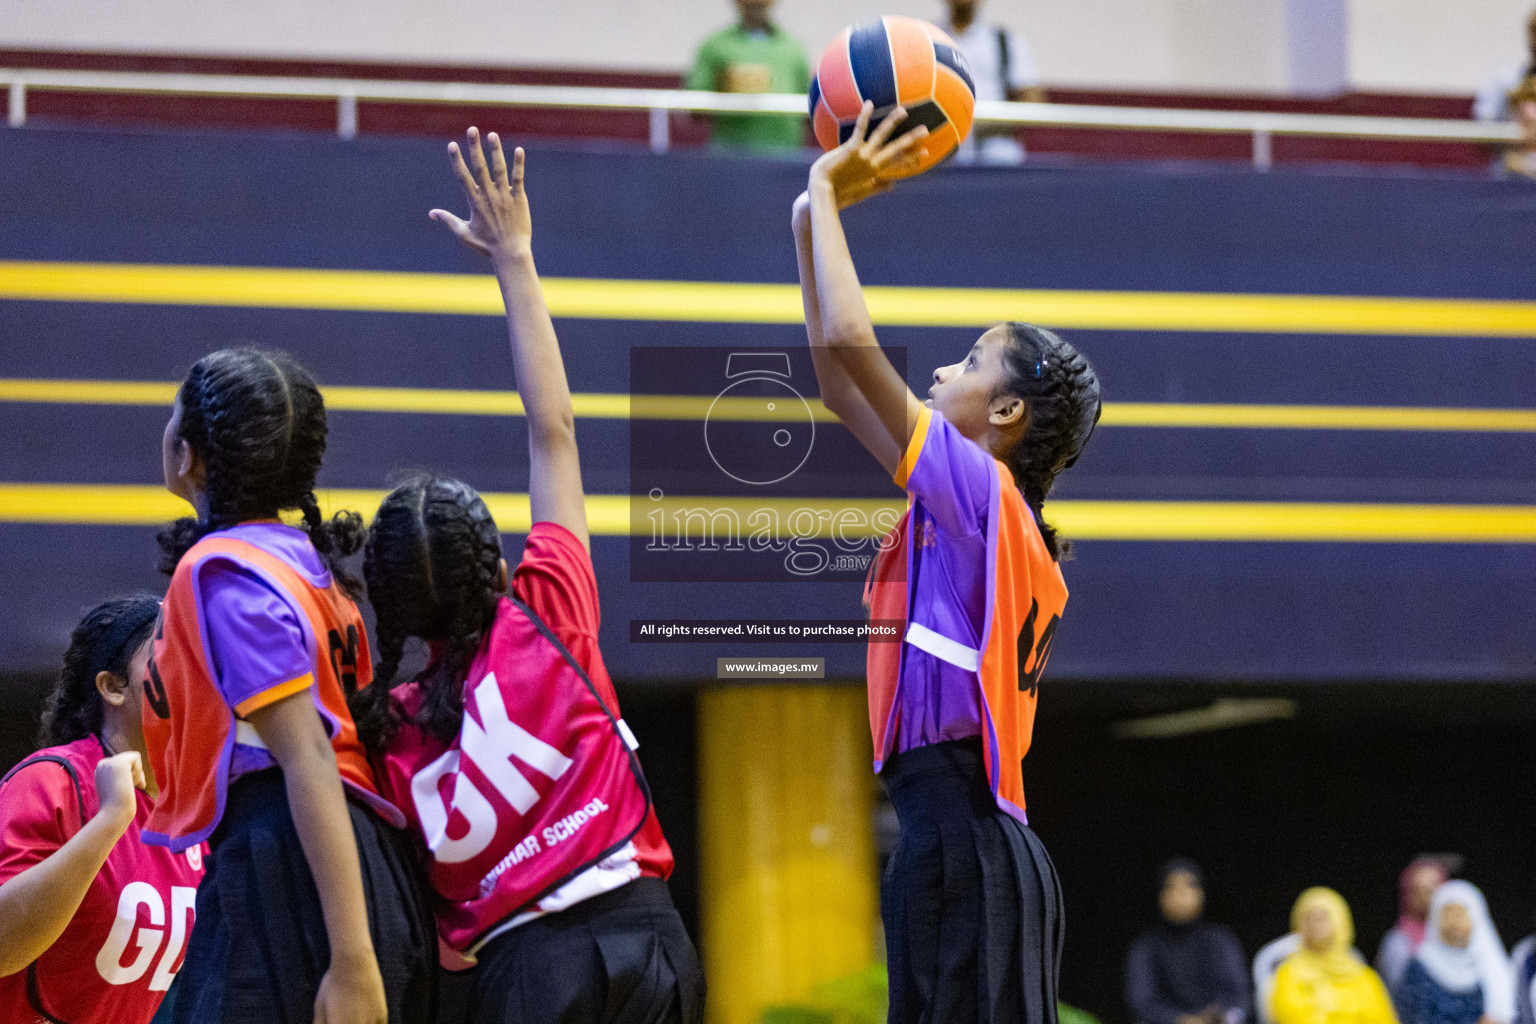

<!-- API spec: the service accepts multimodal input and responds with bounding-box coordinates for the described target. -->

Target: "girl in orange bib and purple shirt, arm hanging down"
[144,348,436,1024]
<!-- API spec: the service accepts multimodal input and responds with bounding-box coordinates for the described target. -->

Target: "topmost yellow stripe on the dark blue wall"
[0,261,1536,338]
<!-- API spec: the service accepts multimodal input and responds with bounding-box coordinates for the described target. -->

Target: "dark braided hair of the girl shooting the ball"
[998,321,1101,560]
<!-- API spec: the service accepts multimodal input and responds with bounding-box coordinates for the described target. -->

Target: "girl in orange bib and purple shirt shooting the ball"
[794,103,1100,1024]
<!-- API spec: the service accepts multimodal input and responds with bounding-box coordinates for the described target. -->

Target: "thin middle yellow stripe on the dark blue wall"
[9,378,1536,433]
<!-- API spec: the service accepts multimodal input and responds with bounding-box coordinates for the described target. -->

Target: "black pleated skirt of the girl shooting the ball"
[880,738,1064,1024]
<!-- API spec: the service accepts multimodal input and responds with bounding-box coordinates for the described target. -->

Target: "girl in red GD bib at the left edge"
[0,596,203,1024]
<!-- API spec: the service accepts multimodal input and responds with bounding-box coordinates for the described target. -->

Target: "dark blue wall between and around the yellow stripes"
[0,130,1536,680]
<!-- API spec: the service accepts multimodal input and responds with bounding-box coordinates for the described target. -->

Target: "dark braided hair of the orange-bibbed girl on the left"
[157,348,362,597]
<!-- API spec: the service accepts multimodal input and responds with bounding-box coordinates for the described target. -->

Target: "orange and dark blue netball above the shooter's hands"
[811,14,975,177]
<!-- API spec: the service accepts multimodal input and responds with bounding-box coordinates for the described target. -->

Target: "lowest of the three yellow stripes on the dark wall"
[0,484,1536,543]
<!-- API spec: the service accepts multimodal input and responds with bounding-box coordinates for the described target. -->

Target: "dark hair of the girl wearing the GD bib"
[37,594,160,746]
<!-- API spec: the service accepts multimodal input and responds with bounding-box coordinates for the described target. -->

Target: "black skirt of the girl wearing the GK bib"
[441,878,703,1024]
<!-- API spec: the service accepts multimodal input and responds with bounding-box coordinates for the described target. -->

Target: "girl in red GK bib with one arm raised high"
[353,127,703,1024]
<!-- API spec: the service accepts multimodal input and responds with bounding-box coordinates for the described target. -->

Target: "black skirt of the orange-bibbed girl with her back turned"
[172,769,438,1024]
